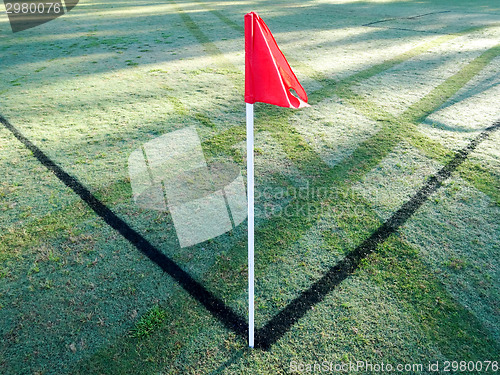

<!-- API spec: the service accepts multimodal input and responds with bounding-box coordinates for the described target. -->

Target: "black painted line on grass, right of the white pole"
[256,121,500,350]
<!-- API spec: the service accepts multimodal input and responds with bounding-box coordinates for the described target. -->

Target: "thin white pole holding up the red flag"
[246,103,255,348]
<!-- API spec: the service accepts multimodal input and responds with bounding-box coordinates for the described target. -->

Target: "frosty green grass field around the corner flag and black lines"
[0,0,500,375]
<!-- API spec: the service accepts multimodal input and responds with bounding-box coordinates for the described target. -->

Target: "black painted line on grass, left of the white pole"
[0,115,248,337]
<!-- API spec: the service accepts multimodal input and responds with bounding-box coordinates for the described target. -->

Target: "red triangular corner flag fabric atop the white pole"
[245,12,309,108]
